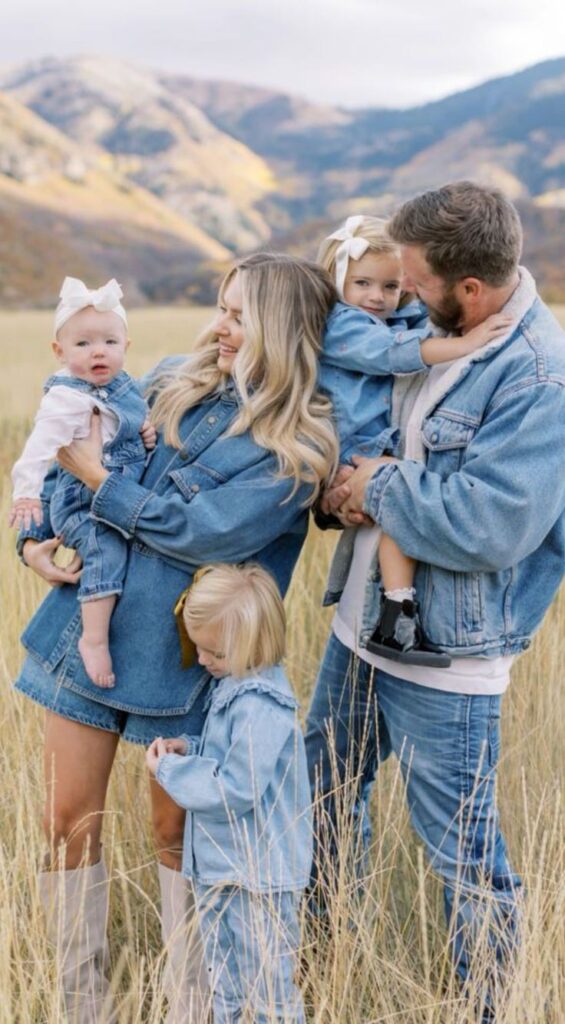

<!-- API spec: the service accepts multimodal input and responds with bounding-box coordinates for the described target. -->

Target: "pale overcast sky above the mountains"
[0,0,565,106]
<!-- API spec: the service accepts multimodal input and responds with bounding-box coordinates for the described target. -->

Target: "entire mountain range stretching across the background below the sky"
[0,56,565,302]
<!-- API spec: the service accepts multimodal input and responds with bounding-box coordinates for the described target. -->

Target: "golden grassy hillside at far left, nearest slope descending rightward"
[0,84,229,305]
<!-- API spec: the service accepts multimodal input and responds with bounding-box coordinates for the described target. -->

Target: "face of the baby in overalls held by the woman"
[53,306,129,387]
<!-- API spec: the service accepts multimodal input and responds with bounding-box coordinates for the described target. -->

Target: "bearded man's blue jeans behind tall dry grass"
[306,634,521,979]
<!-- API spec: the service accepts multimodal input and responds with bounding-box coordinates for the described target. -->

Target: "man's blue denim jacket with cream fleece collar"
[325,268,565,656]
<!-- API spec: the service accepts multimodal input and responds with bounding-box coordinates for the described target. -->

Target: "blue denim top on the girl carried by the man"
[318,301,431,463]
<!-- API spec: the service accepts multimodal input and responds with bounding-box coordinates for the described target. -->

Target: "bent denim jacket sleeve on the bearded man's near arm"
[363,382,565,572]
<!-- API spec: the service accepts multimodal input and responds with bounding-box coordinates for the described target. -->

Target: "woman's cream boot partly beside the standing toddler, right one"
[159,864,211,1024]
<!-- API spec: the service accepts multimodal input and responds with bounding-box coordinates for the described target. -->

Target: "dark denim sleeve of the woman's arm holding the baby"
[91,455,310,566]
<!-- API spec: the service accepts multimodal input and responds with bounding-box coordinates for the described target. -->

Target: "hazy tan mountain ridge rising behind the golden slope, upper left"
[0,56,274,250]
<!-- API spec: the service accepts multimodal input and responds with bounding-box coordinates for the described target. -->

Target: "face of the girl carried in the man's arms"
[343,252,402,318]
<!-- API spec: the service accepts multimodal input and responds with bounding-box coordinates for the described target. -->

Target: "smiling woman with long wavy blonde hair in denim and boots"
[16,254,337,1022]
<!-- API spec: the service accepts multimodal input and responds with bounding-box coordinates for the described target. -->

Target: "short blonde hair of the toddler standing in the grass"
[182,562,286,677]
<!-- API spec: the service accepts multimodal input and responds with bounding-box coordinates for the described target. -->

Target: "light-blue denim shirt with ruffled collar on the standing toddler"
[156,666,312,892]
